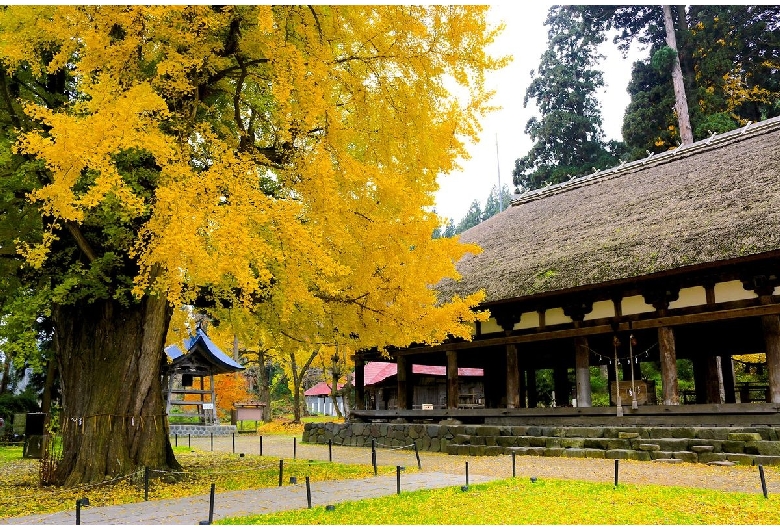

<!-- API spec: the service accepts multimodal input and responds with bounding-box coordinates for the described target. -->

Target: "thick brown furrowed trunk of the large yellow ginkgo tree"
[52,297,179,486]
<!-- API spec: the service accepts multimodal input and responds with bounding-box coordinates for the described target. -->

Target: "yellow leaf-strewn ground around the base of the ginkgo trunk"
[0,447,395,518]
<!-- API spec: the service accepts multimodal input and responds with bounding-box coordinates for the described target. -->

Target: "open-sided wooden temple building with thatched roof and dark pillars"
[353,118,780,424]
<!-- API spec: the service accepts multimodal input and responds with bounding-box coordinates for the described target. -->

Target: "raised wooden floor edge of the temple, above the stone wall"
[351,403,780,427]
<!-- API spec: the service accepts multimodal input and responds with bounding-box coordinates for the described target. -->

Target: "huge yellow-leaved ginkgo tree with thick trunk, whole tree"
[0,6,506,485]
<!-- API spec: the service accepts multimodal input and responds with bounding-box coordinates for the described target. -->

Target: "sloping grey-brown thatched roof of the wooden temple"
[438,118,780,302]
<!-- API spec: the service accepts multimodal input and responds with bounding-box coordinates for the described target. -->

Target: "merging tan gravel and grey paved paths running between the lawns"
[0,435,780,524]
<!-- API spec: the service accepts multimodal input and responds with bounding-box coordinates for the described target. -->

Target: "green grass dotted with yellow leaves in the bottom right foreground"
[218,478,780,525]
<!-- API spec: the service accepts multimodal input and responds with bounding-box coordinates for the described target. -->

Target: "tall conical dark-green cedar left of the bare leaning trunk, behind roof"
[512,6,617,189]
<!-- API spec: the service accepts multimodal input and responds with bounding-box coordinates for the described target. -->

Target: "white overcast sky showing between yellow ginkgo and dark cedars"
[436,2,642,224]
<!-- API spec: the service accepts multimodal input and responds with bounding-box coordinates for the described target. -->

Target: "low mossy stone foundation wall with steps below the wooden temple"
[303,423,780,465]
